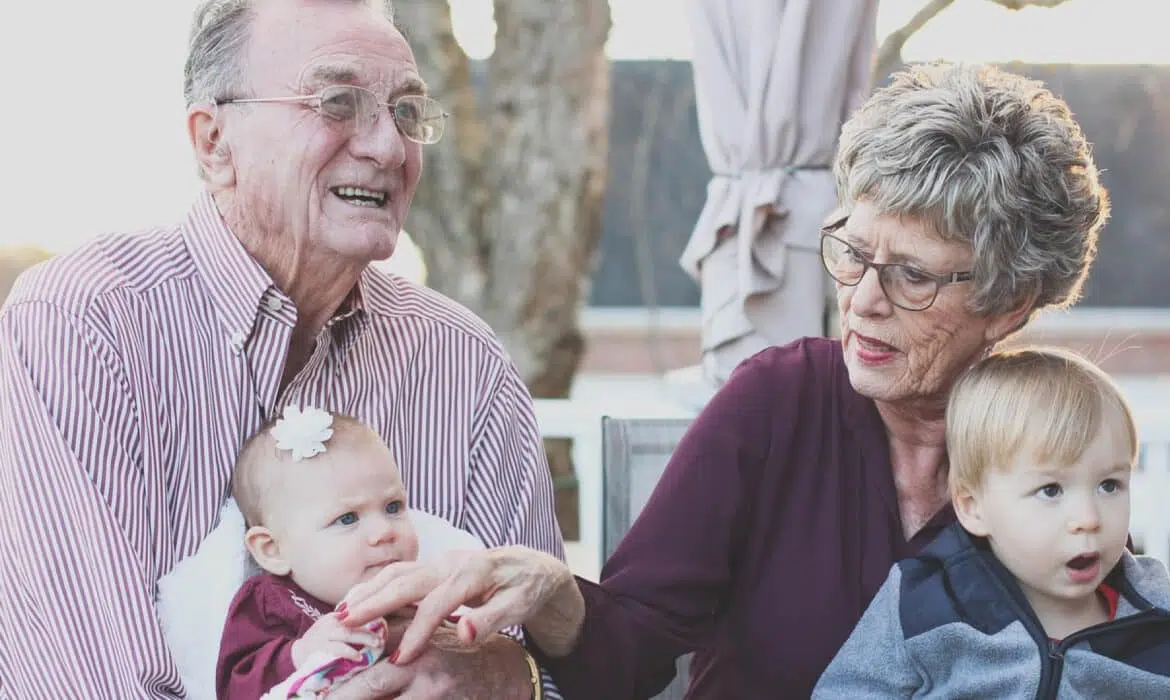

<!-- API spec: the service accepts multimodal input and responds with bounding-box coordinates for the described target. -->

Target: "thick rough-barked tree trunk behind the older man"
[395,0,610,536]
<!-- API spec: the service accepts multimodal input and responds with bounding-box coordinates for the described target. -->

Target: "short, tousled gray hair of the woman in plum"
[833,62,1109,316]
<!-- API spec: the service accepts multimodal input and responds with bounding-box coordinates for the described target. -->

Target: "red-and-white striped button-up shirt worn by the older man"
[0,194,563,700]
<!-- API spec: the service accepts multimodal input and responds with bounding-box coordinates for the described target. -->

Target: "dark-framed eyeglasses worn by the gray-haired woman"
[820,219,971,311]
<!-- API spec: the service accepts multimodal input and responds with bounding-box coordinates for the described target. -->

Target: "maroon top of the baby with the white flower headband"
[215,574,331,700]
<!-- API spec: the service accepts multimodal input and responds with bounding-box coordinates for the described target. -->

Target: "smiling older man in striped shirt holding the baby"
[0,0,563,700]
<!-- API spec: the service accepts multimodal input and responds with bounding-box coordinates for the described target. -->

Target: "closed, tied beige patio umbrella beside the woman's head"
[680,0,878,384]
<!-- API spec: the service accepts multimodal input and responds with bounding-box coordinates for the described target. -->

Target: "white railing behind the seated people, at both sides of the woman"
[536,379,1170,579]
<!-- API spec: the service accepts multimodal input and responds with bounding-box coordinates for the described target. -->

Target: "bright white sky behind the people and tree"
[0,0,1151,249]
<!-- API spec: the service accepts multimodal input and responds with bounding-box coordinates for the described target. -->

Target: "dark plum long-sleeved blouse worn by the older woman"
[536,338,955,700]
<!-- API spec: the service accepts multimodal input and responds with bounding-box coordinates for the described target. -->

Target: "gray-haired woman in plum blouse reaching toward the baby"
[336,64,1108,699]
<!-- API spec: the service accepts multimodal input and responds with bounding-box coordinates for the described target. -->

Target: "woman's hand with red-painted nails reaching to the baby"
[339,547,585,664]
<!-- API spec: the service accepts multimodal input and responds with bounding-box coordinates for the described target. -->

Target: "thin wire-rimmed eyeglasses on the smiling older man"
[215,85,449,145]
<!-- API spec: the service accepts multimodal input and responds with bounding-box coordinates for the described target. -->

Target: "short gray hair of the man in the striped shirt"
[183,0,394,107]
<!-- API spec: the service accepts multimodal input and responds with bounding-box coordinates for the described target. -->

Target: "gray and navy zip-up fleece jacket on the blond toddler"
[813,524,1170,700]
